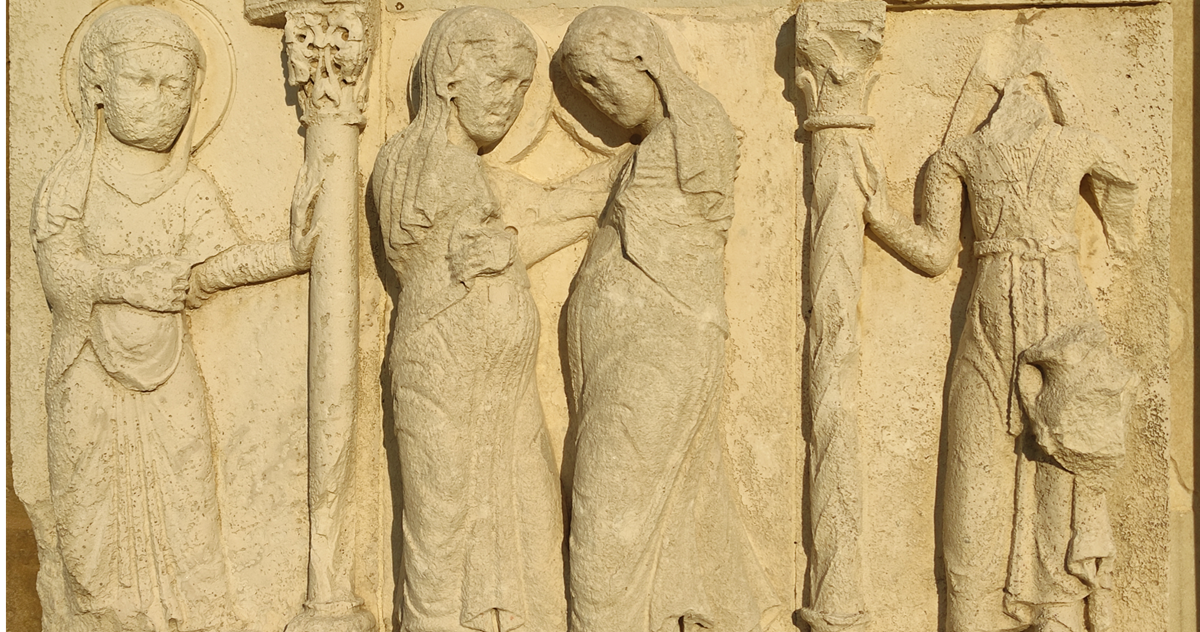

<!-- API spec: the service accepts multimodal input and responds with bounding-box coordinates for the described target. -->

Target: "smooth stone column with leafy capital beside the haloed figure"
[246,0,374,632]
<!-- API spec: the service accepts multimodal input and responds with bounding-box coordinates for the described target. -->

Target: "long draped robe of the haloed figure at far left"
[38,167,236,632]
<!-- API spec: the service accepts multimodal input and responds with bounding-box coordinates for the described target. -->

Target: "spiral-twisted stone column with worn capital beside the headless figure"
[796,1,886,632]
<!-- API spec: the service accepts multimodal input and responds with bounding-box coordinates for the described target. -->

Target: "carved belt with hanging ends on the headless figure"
[974,235,1079,437]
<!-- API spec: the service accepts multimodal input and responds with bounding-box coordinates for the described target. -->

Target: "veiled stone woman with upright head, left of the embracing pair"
[372,7,566,632]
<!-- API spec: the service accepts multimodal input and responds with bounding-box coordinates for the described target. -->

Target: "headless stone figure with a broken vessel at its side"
[863,26,1138,632]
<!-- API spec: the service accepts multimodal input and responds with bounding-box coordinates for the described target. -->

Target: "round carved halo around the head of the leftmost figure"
[60,0,236,152]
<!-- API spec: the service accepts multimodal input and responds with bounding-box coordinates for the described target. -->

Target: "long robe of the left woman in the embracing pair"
[380,145,566,632]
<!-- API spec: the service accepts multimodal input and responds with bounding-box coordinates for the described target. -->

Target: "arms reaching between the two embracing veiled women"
[487,152,629,266]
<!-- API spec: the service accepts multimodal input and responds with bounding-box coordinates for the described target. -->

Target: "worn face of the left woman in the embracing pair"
[450,46,536,148]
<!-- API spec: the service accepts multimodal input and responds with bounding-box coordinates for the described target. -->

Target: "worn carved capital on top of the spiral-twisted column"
[796,0,887,132]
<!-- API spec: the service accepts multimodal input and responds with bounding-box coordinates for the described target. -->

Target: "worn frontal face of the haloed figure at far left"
[101,44,196,151]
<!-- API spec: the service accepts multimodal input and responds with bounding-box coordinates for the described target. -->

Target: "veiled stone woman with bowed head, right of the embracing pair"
[559,7,779,632]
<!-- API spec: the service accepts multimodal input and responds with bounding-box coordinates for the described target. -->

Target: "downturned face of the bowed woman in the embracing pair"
[564,50,662,130]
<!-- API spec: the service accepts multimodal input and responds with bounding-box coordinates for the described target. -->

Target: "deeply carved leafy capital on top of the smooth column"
[283,5,371,126]
